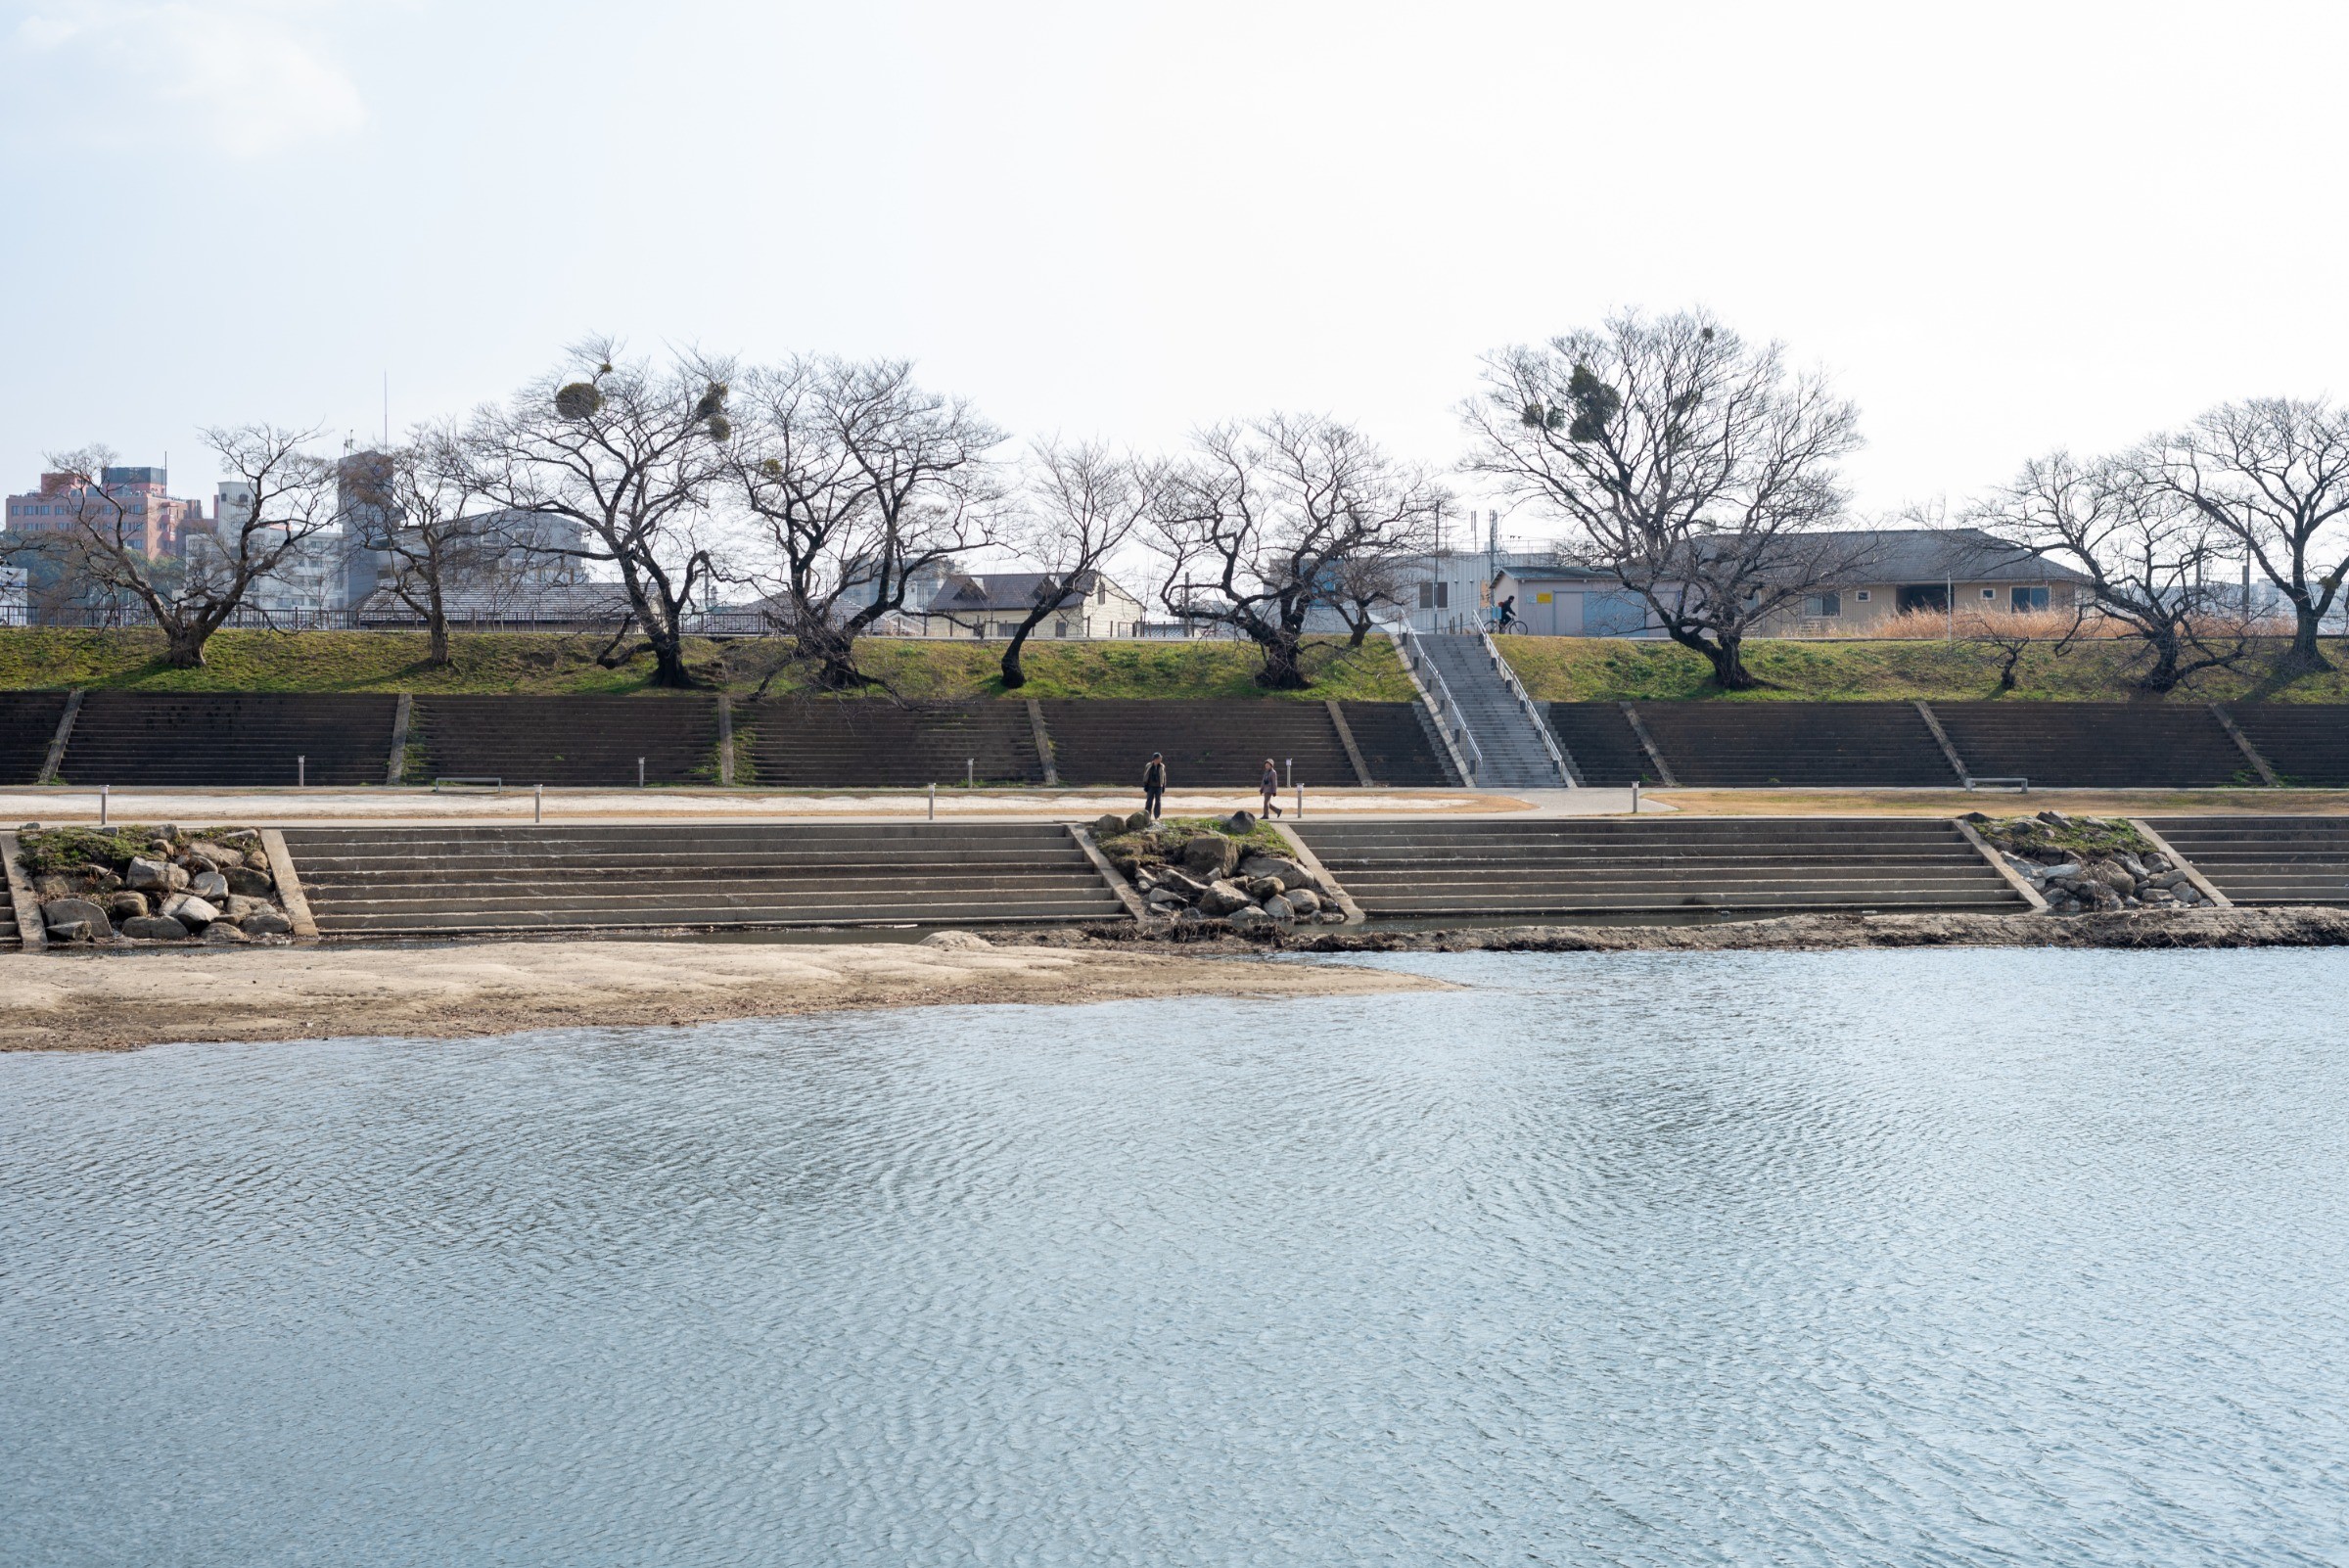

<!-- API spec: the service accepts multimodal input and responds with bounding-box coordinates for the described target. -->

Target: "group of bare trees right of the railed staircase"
[1466,312,2349,690]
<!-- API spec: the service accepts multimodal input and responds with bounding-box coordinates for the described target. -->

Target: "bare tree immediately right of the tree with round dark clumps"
[728,359,1003,690]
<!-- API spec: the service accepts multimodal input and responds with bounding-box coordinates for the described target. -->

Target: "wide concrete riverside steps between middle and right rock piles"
[1299,817,2025,918]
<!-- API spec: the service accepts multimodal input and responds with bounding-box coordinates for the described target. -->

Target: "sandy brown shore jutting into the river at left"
[0,942,1445,1051]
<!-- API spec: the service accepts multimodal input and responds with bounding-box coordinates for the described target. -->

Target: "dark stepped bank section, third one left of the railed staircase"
[735,700,1043,789]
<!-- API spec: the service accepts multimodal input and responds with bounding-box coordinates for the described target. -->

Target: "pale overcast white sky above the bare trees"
[0,0,2349,539]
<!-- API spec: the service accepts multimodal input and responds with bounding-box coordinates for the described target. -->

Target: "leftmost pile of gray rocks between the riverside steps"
[33,826,294,944]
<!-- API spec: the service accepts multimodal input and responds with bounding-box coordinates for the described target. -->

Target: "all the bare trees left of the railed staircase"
[4,338,1443,690]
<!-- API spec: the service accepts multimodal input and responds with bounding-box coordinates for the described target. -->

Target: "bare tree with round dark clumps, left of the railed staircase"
[463,338,733,688]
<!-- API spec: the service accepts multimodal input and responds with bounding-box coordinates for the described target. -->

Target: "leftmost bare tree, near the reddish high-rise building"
[14,425,336,669]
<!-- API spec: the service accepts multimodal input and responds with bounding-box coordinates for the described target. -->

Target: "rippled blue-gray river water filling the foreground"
[0,950,2349,1568]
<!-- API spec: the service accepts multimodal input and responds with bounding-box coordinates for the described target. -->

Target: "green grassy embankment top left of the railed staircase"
[0,626,1414,702]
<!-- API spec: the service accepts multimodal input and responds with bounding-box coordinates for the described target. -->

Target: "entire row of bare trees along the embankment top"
[7,312,2349,690]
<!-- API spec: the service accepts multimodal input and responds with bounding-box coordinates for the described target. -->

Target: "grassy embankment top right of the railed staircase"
[1497,636,2349,702]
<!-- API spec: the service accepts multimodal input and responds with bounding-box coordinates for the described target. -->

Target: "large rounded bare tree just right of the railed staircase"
[1463,312,1867,690]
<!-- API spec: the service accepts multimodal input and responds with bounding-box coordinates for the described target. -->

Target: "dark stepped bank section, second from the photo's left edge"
[59,692,399,786]
